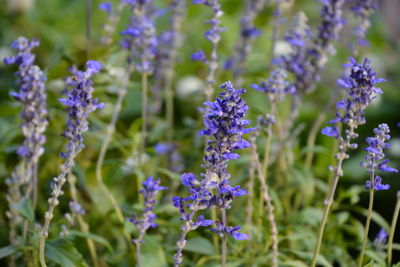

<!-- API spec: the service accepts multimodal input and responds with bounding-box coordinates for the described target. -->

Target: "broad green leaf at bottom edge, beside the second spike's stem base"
[46,239,88,267]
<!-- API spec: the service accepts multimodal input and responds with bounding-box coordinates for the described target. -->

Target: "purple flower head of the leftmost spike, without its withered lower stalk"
[4,37,48,182]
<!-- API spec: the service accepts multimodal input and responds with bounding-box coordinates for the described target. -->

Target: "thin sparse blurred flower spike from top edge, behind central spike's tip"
[192,0,225,101]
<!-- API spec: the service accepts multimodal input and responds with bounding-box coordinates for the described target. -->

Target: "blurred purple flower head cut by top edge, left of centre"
[121,0,157,74]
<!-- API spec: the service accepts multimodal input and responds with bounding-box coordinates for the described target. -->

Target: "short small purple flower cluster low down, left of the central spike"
[128,176,167,243]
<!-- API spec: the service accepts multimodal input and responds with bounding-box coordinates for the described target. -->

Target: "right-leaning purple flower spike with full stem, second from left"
[39,60,104,266]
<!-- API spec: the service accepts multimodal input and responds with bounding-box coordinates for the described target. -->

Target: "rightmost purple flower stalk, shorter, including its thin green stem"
[358,123,398,267]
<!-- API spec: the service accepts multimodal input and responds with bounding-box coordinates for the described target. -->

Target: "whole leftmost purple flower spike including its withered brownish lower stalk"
[4,37,48,248]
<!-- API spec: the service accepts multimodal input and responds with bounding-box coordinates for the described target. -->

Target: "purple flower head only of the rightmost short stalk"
[360,123,398,190]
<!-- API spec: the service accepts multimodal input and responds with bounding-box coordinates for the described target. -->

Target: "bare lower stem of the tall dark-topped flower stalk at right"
[311,156,345,267]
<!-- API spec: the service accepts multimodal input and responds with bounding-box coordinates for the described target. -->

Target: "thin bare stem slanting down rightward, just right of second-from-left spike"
[68,173,99,267]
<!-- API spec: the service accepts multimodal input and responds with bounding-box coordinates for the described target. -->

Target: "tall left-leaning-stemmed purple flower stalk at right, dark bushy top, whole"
[311,58,384,266]
